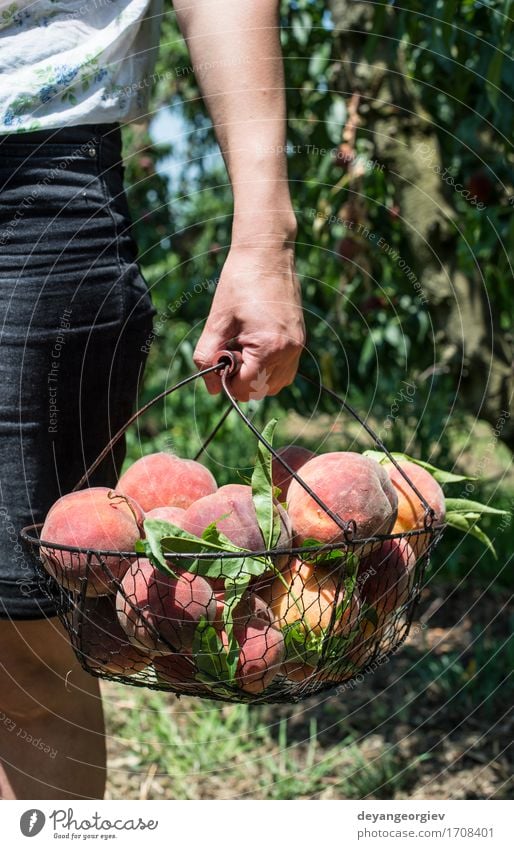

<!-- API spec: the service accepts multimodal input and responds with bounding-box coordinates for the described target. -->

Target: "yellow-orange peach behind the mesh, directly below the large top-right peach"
[261,560,360,637]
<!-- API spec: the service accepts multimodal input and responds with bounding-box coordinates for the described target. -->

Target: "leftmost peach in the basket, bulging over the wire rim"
[41,486,143,596]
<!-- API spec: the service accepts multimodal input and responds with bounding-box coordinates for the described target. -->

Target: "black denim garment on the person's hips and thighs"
[0,125,154,619]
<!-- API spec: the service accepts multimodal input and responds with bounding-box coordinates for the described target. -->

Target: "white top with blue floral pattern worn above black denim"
[0,0,162,133]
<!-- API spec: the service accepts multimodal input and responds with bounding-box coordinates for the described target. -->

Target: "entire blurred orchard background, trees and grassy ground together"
[102,0,514,799]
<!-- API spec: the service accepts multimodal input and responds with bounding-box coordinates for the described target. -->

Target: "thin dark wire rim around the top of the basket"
[20,522,446,560]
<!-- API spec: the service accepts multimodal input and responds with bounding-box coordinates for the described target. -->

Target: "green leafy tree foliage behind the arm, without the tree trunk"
[118,0,514,588]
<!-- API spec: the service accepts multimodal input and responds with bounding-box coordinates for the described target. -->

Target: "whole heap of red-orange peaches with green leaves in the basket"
[41,422,497,696]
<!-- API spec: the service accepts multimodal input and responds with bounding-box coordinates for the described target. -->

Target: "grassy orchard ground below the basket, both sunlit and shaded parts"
[104,588,514,799]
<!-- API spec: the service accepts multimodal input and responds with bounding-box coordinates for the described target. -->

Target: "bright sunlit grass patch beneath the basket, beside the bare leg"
[104,691,420,799]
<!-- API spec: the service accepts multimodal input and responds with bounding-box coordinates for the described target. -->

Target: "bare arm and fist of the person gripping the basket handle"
[174,0,305,400]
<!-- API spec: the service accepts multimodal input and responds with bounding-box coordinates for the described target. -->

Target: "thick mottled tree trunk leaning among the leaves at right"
[330,0,514,448]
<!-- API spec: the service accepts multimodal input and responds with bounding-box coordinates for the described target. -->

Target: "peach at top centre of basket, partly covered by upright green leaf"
[182,484,291,551]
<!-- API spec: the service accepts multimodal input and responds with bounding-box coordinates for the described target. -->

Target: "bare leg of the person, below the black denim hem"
[0,618,105,799]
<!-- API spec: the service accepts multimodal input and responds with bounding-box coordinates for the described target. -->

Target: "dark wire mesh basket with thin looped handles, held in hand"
[21,351,444,704]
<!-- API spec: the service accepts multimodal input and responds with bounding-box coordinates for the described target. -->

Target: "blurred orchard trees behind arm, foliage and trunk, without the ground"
[119,0,508,575]
